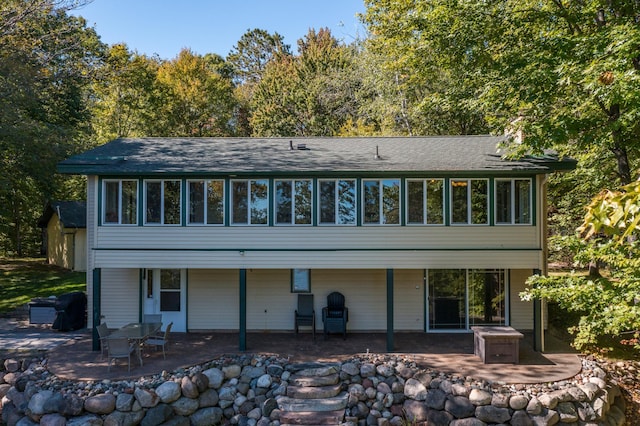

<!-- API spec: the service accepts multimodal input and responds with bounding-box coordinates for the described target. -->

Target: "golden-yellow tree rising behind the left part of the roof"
[154,49,235,136]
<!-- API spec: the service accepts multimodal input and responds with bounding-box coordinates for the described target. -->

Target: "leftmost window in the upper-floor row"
[102,180,138,225]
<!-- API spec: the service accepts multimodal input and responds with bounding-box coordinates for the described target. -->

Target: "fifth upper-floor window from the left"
[275,180,313,225]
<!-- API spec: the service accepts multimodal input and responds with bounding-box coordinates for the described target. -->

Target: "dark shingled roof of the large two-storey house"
[58,136,575,175]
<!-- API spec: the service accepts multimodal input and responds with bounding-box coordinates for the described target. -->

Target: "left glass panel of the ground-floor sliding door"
[427,269,467,330]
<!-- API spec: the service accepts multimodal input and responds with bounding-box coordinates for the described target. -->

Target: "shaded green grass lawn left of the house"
[0,258,87,316]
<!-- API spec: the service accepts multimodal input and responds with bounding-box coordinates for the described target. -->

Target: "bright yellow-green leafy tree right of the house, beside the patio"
[521,181,640,349]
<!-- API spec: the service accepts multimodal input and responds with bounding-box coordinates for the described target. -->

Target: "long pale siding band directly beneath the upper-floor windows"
[97,225,540,251]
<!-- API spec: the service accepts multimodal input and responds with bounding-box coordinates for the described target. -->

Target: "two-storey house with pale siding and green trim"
[58,136,575,351]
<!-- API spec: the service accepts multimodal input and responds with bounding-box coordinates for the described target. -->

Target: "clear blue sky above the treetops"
[72,0,365,59]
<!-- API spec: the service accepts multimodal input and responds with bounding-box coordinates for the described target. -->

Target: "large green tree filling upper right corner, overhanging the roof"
[365,0,640,183]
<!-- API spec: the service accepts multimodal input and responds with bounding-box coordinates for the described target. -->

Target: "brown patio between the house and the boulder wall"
[48,332,582,383]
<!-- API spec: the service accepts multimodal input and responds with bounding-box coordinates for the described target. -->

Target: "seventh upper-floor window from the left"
[362,179,400,225]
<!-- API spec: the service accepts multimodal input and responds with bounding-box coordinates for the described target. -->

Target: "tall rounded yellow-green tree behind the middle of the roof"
[251,29,357,136]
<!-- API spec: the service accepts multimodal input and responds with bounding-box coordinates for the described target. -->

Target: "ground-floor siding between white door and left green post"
[187,269,240,331]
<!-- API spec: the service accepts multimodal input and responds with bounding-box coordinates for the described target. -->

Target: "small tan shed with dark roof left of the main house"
[38,201,87,271]
